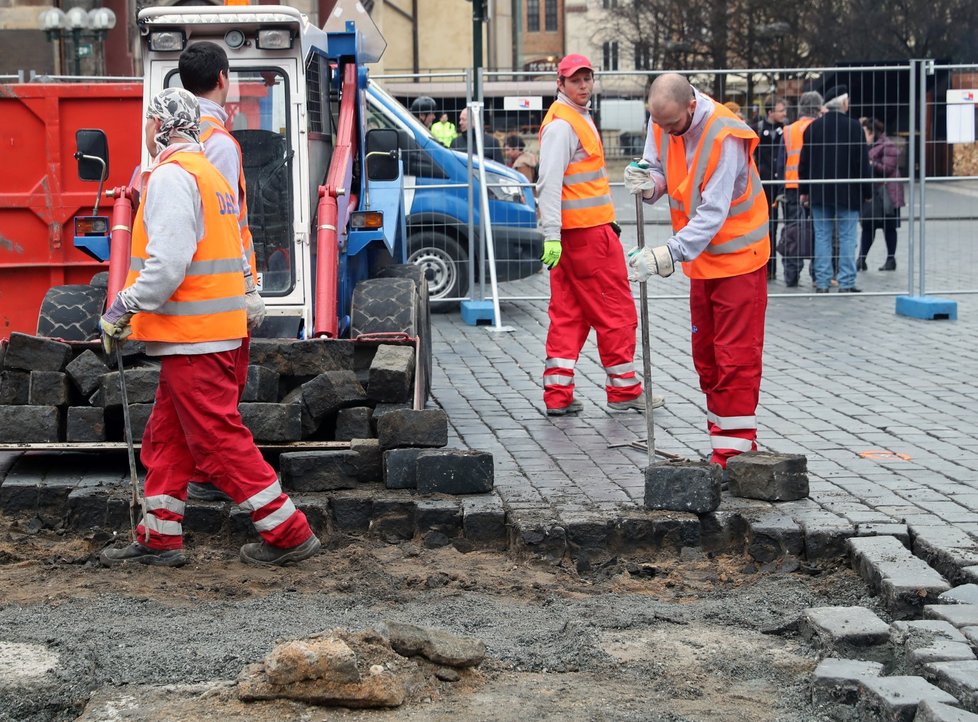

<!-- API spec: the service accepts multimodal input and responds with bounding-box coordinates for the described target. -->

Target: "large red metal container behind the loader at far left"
[0,83,143,338]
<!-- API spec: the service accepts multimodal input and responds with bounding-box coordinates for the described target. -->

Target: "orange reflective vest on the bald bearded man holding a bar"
[652,99,771,279]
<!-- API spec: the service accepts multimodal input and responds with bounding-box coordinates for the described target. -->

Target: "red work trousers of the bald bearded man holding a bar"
[689,266,767,468]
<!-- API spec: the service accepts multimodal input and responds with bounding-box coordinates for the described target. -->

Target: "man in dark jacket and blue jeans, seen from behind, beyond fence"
[798,85,872,293]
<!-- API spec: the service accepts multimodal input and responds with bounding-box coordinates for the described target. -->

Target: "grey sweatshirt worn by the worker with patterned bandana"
[119,143,241,356]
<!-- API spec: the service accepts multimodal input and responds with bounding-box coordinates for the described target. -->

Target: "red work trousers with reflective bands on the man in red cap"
[543,224,642,409]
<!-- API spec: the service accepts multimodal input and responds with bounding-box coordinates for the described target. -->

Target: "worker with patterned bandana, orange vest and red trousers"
[100,88,320,566]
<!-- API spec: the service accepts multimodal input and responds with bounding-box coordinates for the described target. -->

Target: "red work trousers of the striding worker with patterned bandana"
[136,344,312,549]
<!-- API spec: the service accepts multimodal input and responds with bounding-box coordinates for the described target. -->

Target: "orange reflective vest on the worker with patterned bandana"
[126,151,248,343]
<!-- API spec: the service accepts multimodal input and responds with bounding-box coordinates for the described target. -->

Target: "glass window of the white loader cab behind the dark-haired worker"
[167,68,295,295]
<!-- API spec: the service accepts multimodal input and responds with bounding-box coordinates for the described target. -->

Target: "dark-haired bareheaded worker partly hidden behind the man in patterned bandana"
[178,40,265,501]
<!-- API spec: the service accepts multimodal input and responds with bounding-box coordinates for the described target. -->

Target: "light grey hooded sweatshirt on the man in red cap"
[537,93,598,241]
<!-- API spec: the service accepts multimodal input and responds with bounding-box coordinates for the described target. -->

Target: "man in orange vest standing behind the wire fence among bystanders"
[778,90,823,288]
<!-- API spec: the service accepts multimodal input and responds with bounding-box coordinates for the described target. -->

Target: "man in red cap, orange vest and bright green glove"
[537,54,663,416]
